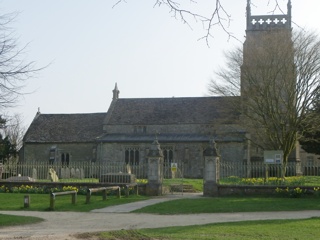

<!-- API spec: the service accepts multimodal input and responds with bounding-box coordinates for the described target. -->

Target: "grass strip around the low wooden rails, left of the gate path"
[0,193,148,212]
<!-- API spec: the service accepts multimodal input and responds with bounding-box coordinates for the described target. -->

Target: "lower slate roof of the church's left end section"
[24,113,106,143]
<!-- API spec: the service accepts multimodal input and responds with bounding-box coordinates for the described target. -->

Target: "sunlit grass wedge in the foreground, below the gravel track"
[93,218,320,240]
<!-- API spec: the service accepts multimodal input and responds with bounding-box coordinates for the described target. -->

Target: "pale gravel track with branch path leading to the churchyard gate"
[0,194,320,240]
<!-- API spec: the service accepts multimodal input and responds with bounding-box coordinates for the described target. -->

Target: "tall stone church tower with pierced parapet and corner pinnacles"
[241,0,296,163]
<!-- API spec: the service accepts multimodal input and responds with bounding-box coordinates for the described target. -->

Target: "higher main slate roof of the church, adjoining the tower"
[106,97,238,125]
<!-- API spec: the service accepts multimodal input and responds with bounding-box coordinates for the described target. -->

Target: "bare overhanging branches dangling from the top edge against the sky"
[114,0,283,44]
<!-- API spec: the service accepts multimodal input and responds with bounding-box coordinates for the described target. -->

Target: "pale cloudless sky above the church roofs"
[0,0,320,127]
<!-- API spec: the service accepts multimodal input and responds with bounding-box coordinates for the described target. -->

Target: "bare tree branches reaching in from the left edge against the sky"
[0,14,40,111]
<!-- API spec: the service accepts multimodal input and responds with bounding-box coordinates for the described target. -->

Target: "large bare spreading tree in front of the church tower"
[209,31,320,174]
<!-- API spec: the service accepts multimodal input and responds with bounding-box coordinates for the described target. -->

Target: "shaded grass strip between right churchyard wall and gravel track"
[134,196,320,215]
